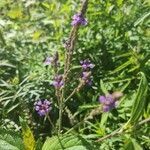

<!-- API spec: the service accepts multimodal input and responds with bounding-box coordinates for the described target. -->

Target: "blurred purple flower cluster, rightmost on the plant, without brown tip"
[99,94,116,112]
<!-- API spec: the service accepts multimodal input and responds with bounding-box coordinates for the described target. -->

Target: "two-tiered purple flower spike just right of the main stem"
[80,59,95,85]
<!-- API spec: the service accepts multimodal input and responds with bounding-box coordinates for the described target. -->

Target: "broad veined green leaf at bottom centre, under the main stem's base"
[42,135,94,150]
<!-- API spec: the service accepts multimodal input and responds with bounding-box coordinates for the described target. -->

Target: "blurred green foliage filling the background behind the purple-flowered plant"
[0,0,150,150]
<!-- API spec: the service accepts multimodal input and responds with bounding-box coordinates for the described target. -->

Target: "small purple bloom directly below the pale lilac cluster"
[52,75,64,88]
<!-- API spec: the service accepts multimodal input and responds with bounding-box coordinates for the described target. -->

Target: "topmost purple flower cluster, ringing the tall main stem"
[71,13,87,26]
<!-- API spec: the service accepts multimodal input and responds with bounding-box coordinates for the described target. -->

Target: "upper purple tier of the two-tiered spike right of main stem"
[80,59,95,70]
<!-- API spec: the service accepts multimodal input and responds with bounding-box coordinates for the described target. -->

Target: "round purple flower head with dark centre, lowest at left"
[34,99,52,116]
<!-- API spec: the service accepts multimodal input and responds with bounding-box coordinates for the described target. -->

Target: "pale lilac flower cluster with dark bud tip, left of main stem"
[44,52,59,67]
